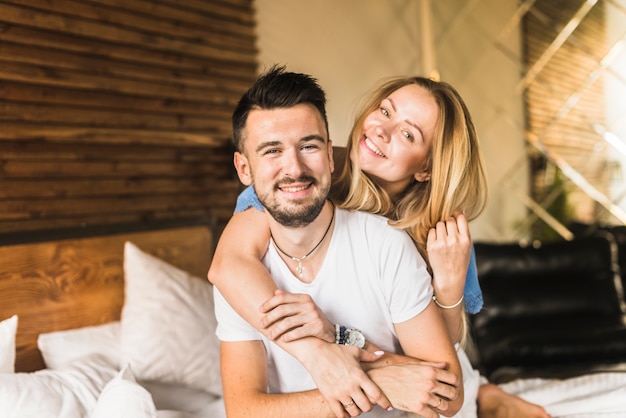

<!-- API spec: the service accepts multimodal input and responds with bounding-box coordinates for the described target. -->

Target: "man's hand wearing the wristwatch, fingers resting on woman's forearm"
[259,290,335,343]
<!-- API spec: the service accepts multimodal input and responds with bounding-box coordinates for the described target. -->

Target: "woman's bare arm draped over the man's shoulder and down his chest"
[208,208,390,416]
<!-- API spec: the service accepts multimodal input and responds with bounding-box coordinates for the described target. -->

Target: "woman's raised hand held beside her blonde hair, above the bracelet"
[426,213,472,306]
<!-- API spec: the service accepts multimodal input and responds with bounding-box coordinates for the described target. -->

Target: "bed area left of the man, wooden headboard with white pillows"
[0,219,225,418]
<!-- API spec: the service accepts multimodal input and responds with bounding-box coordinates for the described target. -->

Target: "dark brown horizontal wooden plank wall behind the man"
[0,0,257,234]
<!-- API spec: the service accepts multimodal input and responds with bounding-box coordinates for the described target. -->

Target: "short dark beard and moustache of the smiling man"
[257,178,330,228]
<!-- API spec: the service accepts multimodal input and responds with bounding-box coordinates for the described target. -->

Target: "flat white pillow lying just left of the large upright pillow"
[37,321,121,370]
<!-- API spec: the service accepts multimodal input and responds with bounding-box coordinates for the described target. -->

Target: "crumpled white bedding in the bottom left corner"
[0,355,117,418]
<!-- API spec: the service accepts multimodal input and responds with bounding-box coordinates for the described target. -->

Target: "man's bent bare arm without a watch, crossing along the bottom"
[221,341,455,418]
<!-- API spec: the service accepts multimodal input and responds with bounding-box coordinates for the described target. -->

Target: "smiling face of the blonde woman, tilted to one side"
[357,84,438,197]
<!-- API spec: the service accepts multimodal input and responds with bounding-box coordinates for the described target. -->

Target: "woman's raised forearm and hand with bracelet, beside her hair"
[426,214,472,343]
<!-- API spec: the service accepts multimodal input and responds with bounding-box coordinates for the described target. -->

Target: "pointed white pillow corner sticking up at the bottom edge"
[91,365,157,418]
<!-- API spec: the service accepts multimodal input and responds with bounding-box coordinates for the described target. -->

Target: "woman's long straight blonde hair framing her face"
[334,77,487,346]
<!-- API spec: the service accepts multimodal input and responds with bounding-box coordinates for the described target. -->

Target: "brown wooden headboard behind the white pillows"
[0,219,214,372]
